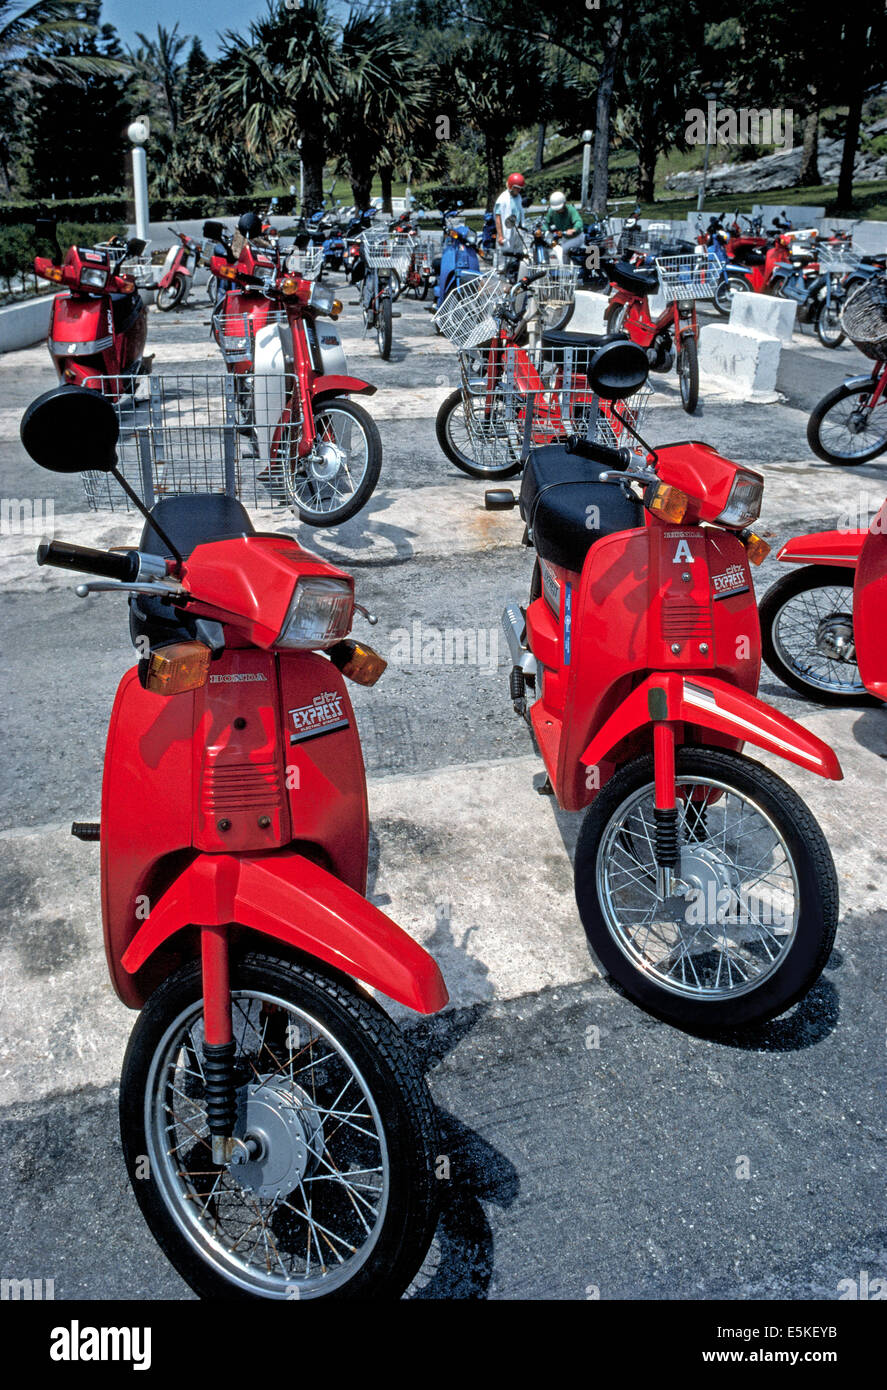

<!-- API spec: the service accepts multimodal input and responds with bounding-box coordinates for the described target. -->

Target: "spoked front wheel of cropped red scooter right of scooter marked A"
[760,566,879,705]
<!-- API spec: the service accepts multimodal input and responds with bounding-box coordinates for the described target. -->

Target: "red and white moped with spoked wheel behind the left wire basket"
[210,230,382,525]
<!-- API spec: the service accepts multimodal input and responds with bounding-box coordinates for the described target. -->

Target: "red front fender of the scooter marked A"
[580,671,844,781]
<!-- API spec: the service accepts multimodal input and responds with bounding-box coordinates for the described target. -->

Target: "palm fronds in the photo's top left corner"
[0,0,127,193]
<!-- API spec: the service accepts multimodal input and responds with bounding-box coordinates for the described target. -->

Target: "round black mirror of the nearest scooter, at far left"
[19,385,120,473]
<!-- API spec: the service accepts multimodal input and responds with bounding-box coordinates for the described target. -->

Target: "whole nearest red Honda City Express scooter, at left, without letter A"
[21,386,446,1300]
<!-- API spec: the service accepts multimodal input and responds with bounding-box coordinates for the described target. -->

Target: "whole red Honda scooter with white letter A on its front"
[488,342,841,1030]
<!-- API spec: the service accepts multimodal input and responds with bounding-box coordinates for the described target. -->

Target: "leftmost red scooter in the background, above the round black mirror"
[33,220,153,400]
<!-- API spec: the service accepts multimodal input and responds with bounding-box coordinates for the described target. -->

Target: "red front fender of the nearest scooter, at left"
[122,853,449,1013]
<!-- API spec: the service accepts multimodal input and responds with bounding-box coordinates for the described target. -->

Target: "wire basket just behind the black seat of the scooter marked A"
[450,343,652,470]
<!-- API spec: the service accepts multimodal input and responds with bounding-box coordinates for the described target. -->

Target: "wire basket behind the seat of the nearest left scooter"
[82,373,302,510]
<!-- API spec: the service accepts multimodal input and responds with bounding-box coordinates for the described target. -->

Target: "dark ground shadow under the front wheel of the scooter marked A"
[552,795,845,1052]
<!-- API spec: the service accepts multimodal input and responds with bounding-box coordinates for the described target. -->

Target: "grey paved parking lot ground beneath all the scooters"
[0,282,887,1300]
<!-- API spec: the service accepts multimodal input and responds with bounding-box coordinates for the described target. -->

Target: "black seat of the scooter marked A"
[520,443,644,574]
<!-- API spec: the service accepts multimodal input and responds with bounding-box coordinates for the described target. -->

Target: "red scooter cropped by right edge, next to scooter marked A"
[760,502,887,705]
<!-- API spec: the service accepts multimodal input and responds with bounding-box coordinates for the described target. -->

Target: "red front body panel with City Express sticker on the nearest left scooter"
[101,648,380,1008]
